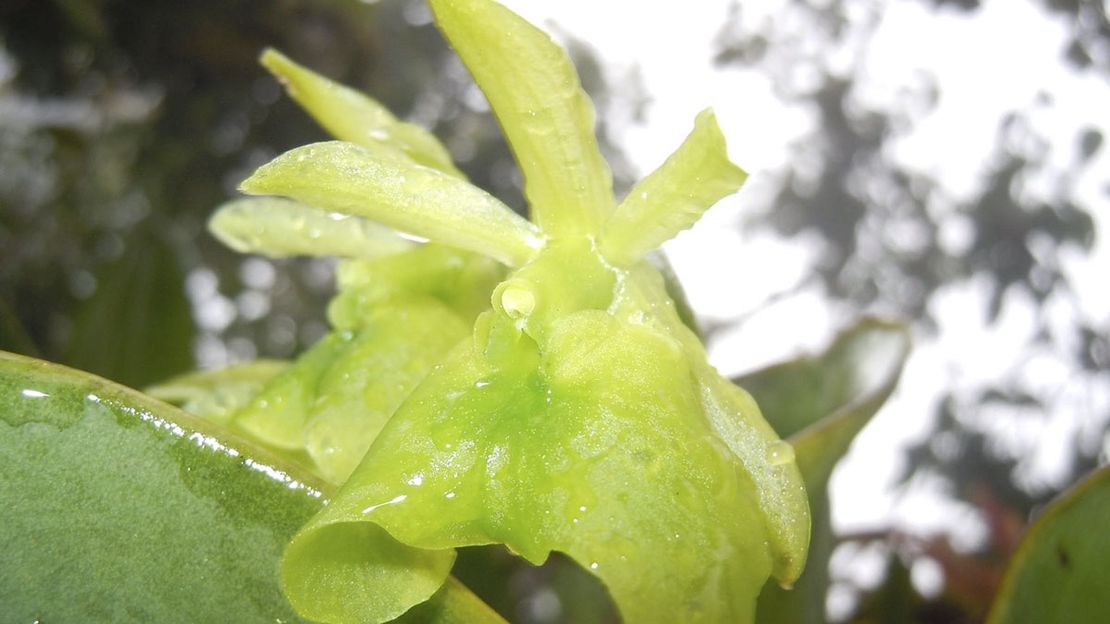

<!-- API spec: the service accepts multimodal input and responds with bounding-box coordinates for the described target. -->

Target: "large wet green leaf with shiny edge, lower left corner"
[0,346,322,623]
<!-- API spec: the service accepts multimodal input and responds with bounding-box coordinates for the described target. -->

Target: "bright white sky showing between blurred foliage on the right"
[503,0,1110,581]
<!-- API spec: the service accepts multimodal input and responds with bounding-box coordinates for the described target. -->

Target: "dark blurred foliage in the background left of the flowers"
[0,0,627,386]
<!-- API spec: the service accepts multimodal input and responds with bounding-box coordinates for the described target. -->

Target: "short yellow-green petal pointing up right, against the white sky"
[598,109,747,265]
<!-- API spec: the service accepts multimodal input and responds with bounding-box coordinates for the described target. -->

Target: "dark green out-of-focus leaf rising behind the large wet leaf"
[64,230,196,386]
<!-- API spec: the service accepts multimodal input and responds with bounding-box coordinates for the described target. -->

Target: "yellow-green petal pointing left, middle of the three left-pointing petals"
[241,141,543,266]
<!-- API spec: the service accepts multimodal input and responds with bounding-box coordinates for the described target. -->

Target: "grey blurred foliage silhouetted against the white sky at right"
[717,0,1110,622]
